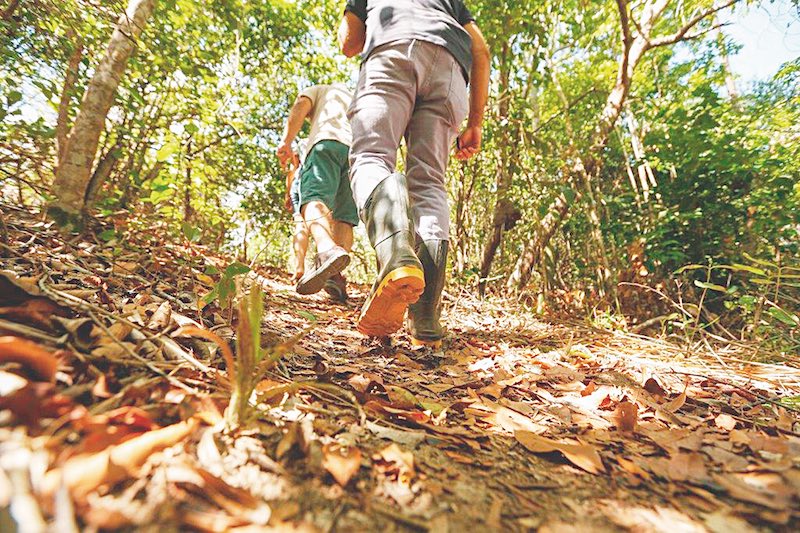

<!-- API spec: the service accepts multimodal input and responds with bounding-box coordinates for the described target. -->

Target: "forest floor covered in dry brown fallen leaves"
[0,203,800,532]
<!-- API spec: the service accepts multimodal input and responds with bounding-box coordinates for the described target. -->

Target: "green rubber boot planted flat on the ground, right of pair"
[408,240,449,348]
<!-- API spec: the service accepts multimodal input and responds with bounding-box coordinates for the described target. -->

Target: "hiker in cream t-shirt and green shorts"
[277,83,358,301]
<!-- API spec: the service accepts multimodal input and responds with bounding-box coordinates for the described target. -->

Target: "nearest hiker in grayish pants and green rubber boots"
[339,0,490,347]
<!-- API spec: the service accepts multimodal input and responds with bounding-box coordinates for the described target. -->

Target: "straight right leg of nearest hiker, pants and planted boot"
[406,44,468,346]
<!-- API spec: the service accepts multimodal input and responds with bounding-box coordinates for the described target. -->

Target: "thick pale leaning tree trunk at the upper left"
[48,0,155,226]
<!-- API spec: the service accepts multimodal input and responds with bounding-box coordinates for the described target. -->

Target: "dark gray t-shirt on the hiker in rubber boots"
[344,0,475,80]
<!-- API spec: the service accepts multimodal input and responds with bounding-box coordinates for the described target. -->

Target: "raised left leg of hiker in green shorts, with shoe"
[296,141,350,294]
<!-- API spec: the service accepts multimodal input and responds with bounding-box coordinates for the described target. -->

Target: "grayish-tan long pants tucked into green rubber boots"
[348,40,468,240]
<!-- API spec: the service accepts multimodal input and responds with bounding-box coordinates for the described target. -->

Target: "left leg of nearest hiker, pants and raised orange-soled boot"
[348,41,425,336]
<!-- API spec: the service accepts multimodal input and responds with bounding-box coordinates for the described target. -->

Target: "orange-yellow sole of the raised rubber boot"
[357,267,425,337]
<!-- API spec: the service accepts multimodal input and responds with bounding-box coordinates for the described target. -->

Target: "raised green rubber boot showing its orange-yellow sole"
[357,173,425,337]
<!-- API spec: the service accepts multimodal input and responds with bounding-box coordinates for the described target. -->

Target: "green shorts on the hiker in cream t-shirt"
[300,140,358,226]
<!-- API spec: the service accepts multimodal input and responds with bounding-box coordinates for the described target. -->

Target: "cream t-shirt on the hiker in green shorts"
[300,83,353,152]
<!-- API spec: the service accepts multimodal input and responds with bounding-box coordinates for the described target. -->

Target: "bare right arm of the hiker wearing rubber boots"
[456,22,491,159]
